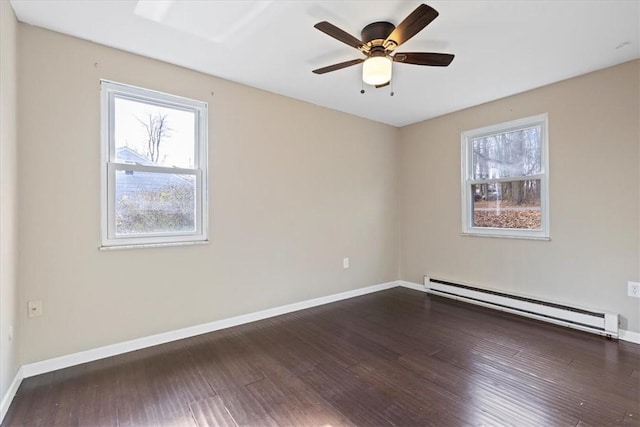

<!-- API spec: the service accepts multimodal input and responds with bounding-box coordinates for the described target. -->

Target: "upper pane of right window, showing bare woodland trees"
[471,126,542,180]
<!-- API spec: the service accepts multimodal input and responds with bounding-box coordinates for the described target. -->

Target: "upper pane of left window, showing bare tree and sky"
[114,97,196,169]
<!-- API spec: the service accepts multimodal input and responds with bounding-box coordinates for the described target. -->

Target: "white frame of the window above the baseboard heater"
[461,113,550,240]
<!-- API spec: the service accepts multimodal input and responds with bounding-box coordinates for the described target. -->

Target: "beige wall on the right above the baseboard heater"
[398,61,640,332]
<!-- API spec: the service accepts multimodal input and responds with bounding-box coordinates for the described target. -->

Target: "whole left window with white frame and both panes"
[101,80,207,247]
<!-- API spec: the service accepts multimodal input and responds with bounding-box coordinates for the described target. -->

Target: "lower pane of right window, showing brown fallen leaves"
[471,179,542,230]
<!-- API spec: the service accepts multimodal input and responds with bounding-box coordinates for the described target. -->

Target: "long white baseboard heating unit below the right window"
[424,276,618,338]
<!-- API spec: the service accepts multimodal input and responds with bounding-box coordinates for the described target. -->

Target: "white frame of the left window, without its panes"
[100,80,208,249]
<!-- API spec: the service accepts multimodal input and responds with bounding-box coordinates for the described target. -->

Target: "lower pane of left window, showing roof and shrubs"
[115,170,196,235]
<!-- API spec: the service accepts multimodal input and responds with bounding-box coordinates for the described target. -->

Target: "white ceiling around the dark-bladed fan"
[11,0,640,126]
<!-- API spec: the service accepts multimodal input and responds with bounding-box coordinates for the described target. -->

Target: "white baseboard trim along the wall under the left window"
[21,281,398,378]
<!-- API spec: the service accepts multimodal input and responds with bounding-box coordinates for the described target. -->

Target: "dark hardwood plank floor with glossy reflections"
[2,288,640,427]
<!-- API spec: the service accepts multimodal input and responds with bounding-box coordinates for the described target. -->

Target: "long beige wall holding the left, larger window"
[18,24,398,363]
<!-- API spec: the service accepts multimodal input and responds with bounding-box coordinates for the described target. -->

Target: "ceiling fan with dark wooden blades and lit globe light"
[313,4,454,88]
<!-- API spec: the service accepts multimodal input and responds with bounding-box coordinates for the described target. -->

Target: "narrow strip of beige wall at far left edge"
[0,1,19,399]
